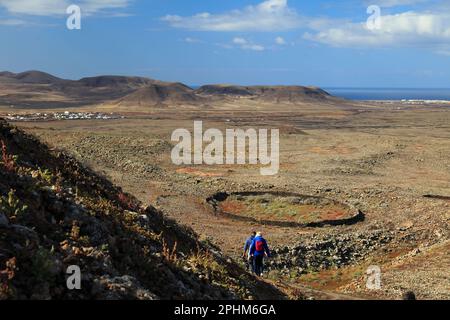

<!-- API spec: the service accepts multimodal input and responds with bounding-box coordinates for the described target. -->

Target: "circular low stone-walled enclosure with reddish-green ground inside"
[207,192,364,227]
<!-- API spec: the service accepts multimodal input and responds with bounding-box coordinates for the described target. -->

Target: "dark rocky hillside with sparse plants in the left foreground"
[0,120,284,299]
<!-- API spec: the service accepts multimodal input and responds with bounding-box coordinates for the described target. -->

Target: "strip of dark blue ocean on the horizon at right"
[324,88,450,101]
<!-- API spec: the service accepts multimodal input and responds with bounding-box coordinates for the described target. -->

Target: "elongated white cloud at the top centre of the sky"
[162,0,302,31]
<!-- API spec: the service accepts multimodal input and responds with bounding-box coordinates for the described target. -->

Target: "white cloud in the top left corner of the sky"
[0,0,131,16]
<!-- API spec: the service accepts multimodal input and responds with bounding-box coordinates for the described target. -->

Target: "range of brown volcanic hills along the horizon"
[0,71,336,108]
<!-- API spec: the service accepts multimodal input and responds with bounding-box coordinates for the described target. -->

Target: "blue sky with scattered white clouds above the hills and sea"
[0,0,450,88]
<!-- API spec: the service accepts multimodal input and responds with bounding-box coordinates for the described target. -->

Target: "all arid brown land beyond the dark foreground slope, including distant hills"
[0,74,450,299]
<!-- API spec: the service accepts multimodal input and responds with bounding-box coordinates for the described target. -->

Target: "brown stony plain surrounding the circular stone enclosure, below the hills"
[7,98,450,299]
